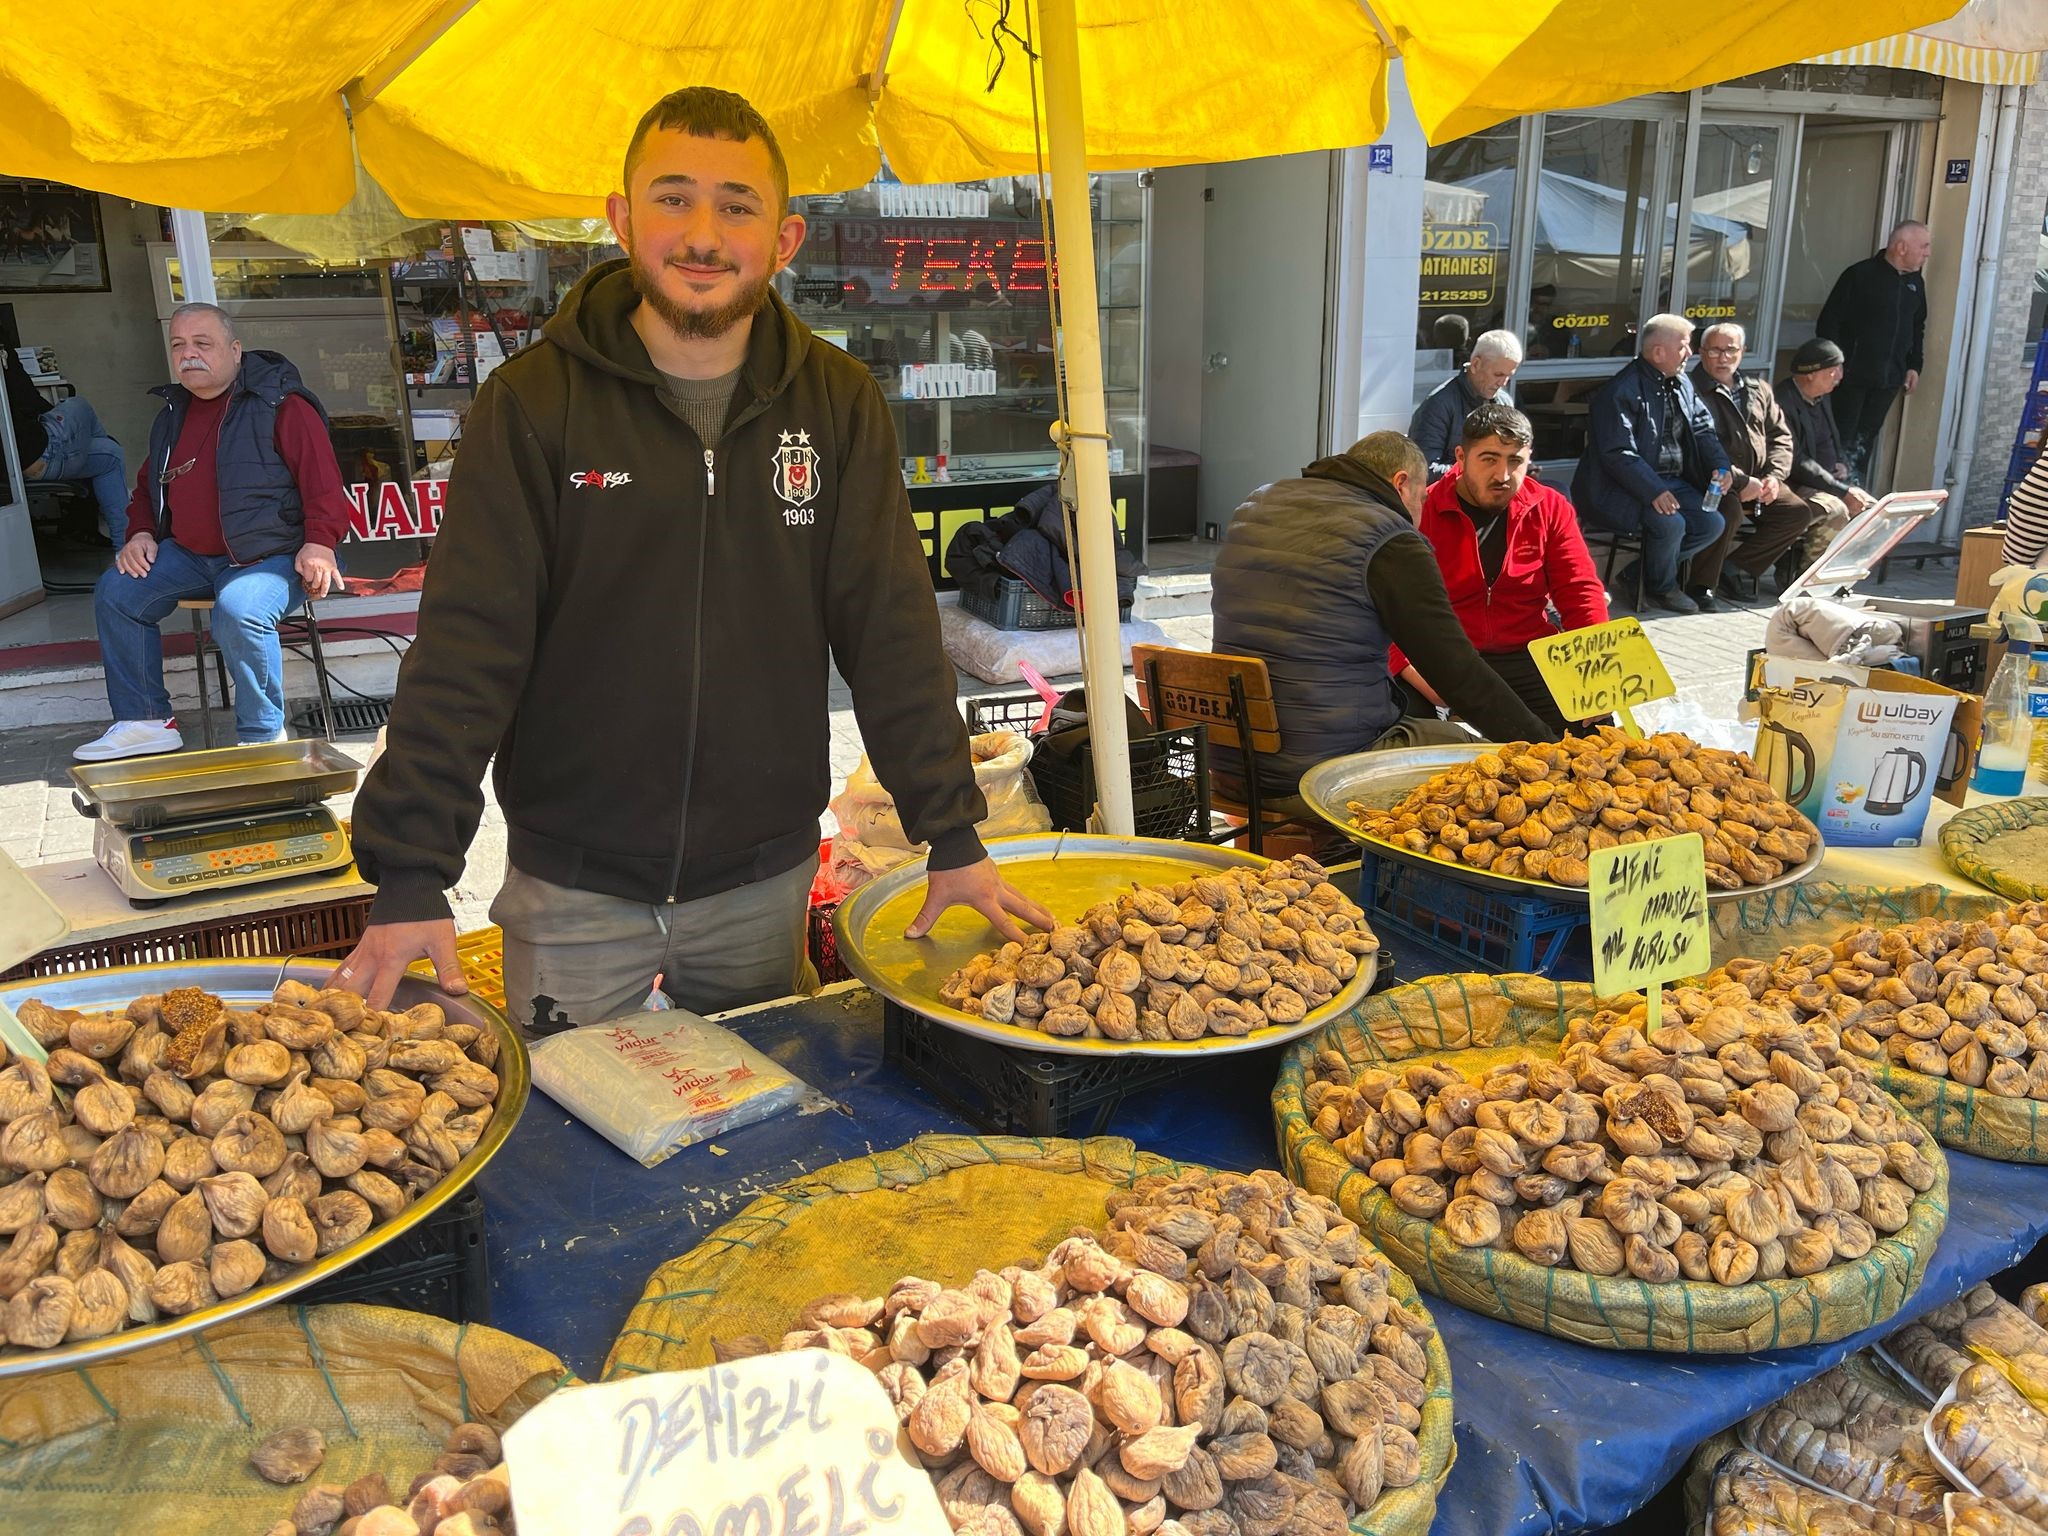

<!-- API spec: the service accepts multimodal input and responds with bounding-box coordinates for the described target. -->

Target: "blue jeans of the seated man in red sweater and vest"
[92,539,305,741]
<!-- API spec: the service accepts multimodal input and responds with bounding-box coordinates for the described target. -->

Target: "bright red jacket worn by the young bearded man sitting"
[1386,473,1608,678]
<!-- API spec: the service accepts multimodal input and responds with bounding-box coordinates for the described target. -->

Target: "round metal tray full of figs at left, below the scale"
[0,961,526,1374]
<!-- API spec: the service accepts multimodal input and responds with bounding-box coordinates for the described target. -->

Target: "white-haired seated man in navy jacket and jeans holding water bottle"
[1571,315,1729,612]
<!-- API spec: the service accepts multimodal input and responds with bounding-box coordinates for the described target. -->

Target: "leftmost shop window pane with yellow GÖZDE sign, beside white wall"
[1415,133,1520,391]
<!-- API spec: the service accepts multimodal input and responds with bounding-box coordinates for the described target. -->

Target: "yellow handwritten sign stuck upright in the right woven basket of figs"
[1585,831,1712,1028]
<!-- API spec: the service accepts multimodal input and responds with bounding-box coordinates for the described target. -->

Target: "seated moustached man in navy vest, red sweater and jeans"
[72,303,348,762]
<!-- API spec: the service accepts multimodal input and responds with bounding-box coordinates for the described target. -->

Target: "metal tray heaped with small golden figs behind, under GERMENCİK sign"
[1327,725,1821,895]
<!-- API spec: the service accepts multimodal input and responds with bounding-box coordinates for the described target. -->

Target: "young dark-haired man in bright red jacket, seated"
[1389,401,1608,735]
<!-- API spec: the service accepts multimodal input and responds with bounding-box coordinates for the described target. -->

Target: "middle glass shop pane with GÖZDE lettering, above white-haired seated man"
[1528,113,1667,360]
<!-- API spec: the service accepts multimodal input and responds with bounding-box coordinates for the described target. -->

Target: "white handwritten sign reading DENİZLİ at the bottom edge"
[506,1350,948,1536]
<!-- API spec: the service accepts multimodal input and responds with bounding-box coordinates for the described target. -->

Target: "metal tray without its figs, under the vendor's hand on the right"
[831,831,1378,1057]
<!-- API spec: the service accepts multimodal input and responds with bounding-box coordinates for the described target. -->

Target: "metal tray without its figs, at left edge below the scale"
[0,961,530,1378]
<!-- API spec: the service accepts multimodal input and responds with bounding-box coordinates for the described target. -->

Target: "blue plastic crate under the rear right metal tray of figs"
[1358,848,1589,981]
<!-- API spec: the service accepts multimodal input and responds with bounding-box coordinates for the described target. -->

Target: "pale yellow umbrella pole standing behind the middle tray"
[1038,0,1135,836]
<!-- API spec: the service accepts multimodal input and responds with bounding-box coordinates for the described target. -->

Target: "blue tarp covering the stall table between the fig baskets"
[479,987,2048,1536]
